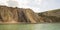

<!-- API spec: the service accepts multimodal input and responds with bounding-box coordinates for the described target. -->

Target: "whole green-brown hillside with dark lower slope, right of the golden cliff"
[37,9,60,22]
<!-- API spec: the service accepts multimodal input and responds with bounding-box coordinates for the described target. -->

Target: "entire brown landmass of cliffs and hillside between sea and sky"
[0,6,60,23]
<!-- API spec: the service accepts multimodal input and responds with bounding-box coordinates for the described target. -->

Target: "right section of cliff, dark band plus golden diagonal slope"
[18,8,43,23]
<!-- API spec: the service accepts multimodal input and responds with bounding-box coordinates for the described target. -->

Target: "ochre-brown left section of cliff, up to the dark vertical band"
[0,6,18,22]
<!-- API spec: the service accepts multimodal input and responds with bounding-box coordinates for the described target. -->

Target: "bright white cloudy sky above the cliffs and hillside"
[0,0,60,12]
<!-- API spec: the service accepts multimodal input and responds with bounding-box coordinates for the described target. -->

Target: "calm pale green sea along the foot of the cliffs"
[0,23,60,30]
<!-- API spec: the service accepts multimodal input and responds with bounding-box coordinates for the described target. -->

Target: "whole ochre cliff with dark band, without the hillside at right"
[0,6,42,23]
